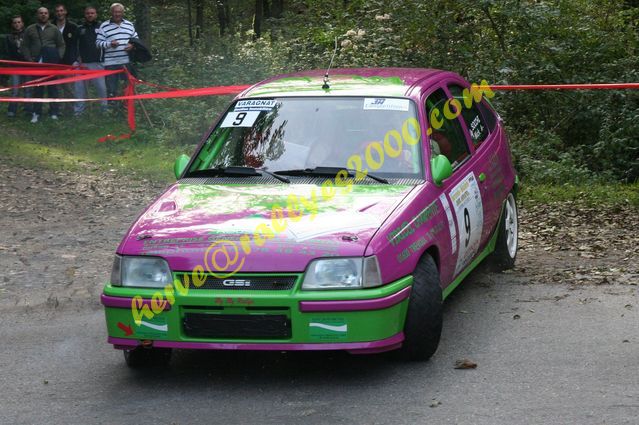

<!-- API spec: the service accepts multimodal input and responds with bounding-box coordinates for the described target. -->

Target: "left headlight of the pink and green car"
[111,255,171,288]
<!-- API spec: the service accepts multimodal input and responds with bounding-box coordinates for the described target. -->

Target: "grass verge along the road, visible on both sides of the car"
[0,113,639,207]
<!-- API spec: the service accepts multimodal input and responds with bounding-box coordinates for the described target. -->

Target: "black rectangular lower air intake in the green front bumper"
[183,313,291,339]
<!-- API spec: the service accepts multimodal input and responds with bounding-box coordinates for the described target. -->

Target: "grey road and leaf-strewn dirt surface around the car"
[0,164,639,424]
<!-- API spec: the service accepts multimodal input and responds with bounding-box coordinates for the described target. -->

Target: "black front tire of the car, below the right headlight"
[398,254,443,361]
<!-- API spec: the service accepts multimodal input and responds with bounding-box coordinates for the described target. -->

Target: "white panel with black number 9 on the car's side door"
[449,173,484,275]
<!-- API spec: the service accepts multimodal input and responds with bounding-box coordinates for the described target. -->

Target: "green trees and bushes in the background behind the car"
[0,0,639,183]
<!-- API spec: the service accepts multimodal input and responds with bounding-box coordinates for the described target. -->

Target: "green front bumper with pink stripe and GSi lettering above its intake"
[102,274,413,351]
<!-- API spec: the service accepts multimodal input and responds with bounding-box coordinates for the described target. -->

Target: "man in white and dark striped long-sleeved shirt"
[96,3,138,103]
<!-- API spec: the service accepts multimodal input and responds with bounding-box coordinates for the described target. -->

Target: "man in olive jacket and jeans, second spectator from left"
[22,7,64,123]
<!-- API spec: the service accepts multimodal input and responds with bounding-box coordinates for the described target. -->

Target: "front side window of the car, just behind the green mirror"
[426,89,470,170]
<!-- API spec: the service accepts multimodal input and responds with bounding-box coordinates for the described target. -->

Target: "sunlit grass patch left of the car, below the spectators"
[0,108,196,183]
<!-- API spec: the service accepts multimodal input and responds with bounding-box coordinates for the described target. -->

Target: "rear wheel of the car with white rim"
[491,192,519,272]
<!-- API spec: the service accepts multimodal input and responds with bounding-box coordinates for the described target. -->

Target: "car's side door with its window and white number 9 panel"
[424,87,484,284]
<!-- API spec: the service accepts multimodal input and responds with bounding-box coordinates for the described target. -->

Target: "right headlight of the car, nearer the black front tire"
[302,256,382,290]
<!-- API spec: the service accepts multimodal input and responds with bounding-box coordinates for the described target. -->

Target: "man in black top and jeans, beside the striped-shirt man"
[74,6,107,116]
